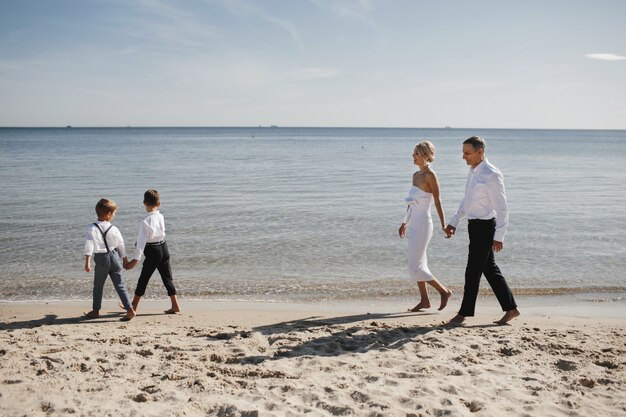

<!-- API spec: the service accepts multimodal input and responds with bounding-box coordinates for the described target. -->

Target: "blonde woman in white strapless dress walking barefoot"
[398,141,452,311]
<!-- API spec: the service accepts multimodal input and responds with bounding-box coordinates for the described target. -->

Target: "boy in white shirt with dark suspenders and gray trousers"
[84,198,135,321]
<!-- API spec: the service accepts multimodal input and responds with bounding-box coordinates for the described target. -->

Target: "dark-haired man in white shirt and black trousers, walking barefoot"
[445,136,520,324]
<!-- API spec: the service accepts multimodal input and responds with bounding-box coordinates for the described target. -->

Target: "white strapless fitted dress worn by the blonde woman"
[404,186,435,281]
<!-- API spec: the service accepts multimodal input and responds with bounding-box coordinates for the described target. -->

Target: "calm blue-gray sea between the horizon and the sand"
[0,128,626,300]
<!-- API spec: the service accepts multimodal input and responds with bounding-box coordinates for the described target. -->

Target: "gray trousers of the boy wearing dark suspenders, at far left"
[93,250,132,310]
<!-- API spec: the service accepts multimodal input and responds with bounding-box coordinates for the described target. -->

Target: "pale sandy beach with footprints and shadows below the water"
[0,301,626,417]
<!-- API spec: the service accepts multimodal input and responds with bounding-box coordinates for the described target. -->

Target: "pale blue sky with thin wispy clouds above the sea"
[0,0,626,129]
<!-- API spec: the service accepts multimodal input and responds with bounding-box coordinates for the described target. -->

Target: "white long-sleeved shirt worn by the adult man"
[449,159,509,242]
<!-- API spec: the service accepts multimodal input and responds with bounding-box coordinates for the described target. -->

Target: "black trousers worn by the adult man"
[459,219,517,317]
